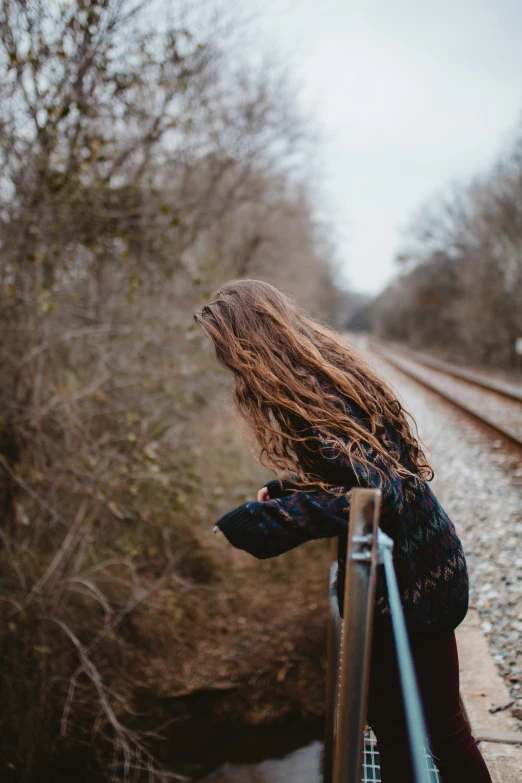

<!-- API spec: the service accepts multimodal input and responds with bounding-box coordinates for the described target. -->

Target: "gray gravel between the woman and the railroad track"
[361,346,522,728]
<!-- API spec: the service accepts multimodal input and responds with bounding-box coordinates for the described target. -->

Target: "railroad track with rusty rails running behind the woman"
[368,339,522,449]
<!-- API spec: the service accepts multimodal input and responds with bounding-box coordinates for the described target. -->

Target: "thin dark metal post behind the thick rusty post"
[323,538,341,783]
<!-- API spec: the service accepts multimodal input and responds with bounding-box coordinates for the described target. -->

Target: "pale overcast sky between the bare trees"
[256,0,522,293]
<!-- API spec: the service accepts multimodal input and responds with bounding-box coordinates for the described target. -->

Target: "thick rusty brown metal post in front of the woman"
[333,488,381,783]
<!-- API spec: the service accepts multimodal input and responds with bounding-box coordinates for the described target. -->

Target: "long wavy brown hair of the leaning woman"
[194,279,434,489]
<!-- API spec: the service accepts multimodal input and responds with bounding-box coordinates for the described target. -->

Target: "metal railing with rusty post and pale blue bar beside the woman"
[323,488,433,783]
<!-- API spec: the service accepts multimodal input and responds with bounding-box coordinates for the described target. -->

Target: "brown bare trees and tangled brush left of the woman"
[0,0,337,781]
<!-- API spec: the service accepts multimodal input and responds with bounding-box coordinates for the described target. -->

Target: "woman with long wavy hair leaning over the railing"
[194,280,491,783]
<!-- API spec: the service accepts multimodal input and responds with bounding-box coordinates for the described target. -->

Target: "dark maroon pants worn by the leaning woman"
[368,629,491,783]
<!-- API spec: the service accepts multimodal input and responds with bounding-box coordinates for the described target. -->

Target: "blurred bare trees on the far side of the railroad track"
[370,123,522,370]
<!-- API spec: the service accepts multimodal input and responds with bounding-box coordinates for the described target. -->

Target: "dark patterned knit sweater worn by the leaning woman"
[212,397,469,632]
